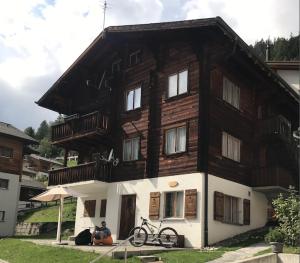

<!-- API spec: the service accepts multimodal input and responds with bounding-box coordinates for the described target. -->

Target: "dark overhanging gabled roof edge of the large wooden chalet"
[36,17,299,110]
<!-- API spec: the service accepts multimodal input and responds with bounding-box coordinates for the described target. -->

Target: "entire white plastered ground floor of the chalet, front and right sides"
[67,173,268,247]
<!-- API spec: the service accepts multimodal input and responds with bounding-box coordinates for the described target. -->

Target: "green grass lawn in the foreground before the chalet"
[0,238,224,263]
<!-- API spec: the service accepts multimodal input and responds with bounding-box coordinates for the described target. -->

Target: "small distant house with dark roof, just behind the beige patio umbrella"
[18,174,46,211]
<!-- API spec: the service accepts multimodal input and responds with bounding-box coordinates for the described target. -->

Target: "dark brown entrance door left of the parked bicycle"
[119,195,136,240]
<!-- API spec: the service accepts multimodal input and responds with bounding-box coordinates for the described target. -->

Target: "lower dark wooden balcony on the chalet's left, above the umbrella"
[48,162,111,186]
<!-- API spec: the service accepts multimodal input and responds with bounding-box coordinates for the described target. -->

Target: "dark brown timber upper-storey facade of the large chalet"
[39,19,299,191]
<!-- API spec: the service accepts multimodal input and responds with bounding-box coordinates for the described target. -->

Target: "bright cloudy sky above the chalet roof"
[0,0,299,129]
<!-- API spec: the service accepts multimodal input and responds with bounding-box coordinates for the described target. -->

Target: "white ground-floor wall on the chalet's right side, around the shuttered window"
[208,175,268,244]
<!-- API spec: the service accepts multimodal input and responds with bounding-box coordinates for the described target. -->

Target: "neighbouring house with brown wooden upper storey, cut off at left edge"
[0,122,37,236]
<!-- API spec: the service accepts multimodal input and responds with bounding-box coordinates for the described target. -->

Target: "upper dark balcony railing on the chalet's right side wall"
[258,115,291,141]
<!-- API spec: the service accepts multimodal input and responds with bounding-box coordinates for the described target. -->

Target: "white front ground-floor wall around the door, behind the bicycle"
[75,173,203,247]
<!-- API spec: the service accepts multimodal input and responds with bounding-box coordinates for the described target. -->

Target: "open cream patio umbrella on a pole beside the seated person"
[31,185,85,244]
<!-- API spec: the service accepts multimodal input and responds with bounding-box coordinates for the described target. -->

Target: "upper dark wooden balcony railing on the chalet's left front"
[51,112,108,142]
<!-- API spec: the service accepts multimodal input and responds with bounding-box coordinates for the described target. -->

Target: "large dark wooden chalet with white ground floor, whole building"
[38,17,299,247]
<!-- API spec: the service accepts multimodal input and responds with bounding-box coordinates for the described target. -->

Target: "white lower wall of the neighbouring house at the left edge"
[0,172,20,236]
